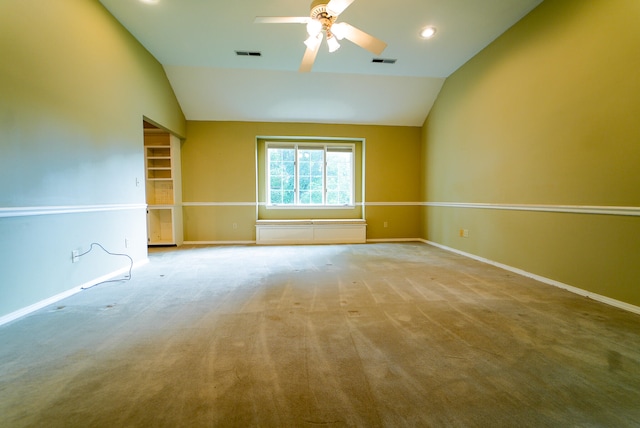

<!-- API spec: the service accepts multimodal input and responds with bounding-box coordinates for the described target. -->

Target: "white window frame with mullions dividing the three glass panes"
[264,141,357,210]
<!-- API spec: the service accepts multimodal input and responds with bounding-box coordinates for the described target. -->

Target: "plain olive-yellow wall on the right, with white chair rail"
[422,0,640,305]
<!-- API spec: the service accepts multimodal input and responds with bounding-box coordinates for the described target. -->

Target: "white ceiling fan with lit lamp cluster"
[254,0,387,72]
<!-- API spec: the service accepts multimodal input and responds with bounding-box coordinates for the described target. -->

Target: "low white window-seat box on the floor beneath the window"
[256,220,367,245]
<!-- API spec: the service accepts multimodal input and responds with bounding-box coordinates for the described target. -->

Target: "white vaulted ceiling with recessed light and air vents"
[100,0,542,126]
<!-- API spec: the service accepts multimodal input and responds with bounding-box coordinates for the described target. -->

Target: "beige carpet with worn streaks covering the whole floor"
[0,243,640,427]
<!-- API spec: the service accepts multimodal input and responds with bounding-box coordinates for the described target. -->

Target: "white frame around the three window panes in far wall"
[264,141,356,210]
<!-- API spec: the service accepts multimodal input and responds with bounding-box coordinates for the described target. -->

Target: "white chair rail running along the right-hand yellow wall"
[422,202,640,217]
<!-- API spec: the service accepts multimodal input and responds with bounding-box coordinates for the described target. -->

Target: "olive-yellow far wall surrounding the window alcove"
[182,121,421,242]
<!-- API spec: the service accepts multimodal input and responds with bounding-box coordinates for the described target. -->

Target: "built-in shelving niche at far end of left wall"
[144,129,183,246]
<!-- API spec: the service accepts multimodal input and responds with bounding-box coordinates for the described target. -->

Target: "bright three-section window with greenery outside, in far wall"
[266,143,355,207]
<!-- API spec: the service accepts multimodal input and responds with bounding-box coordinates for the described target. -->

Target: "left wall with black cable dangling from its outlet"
[0,0,186,317]
